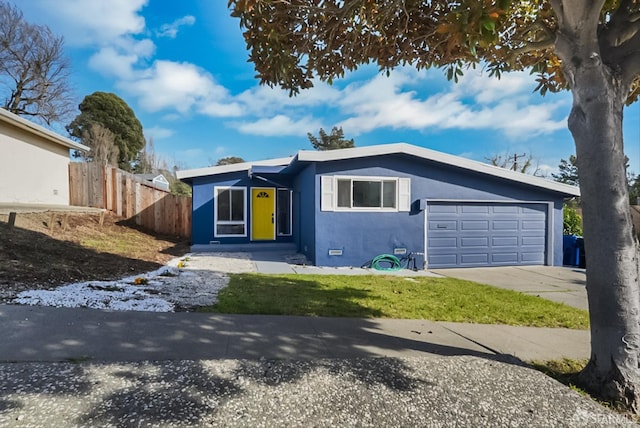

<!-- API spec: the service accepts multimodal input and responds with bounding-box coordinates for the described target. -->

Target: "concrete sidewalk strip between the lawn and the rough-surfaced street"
[0,305,589,361]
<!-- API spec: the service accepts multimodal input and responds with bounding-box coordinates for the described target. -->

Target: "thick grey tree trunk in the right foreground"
[565,49,640,413]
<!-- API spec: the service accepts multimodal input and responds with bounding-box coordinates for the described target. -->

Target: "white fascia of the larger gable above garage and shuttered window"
[298,143,580,196]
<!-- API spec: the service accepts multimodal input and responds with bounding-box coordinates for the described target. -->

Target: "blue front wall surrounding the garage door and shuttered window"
[314,155,563,268]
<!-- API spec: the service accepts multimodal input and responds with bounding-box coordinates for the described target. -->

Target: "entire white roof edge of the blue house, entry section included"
[177,143,580,196]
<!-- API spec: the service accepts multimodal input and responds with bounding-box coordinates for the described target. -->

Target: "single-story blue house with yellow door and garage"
[178,143,579,268]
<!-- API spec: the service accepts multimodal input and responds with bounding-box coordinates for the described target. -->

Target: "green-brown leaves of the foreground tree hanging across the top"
[229,0,640,101]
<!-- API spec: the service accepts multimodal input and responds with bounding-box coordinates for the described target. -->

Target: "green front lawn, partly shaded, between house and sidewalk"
[201,274,589,329]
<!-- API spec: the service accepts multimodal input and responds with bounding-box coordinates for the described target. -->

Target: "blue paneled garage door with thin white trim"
[426,202,548,268]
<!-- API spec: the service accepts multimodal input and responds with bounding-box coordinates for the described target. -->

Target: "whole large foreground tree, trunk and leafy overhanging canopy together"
[228,0,640,412]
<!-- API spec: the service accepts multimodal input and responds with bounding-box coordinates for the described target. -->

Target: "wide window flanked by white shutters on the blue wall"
[321,176,411,211]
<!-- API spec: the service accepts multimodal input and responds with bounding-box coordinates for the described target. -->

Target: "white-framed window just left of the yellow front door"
[213,187,247,237]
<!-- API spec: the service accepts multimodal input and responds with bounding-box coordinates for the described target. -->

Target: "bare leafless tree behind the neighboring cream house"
[0,0,75,125]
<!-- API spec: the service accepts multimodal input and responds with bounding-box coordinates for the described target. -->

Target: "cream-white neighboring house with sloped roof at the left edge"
[0,108,89,205]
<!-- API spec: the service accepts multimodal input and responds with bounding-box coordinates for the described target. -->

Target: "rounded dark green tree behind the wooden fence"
[67,92,146,171]
